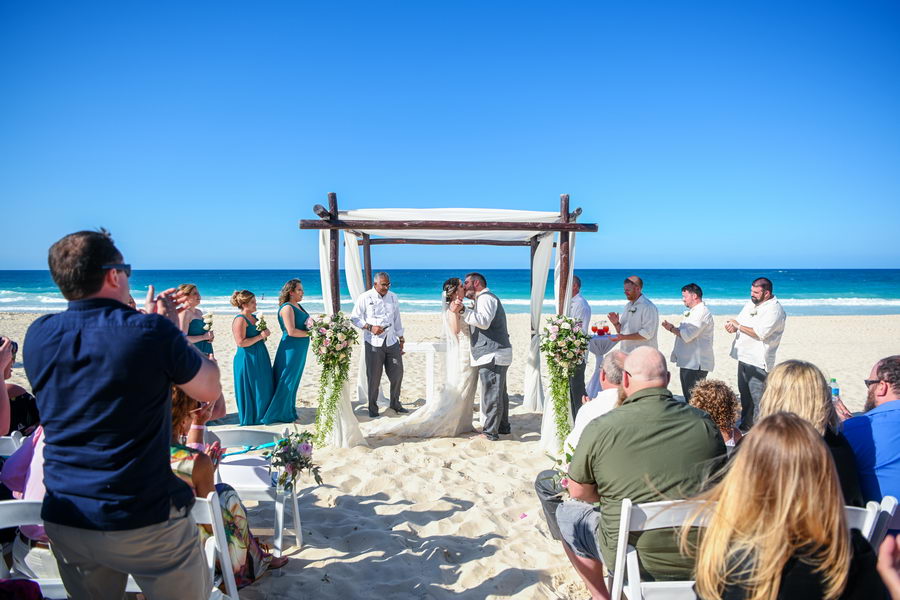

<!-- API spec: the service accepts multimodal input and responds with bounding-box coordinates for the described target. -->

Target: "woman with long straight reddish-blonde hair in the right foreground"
[682,412,887,600]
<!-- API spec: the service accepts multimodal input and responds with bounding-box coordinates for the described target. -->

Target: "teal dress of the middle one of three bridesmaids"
[234,315,272,425]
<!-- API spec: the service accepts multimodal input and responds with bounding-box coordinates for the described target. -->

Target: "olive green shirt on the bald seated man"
[569,388,725,580]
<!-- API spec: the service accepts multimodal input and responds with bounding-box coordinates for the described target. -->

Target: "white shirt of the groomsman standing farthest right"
[731,296,787,372]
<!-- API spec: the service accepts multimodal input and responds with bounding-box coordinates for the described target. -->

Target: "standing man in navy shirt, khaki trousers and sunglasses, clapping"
[24,230,221,600]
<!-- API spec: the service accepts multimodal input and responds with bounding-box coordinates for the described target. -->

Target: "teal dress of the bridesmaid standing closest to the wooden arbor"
[262,303,309,425]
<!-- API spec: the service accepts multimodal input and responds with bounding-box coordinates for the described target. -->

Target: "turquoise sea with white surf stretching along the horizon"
[0,269,900,315]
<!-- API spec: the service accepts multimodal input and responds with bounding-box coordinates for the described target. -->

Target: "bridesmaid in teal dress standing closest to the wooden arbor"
[262,279,309,425]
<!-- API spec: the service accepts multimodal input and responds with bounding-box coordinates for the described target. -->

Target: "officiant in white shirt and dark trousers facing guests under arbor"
[350,273,409,418]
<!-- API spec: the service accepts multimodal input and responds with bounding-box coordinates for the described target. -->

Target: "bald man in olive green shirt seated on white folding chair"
[556,346,725,598]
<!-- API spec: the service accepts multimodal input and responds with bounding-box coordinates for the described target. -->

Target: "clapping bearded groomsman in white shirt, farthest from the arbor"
[725,277,787,433]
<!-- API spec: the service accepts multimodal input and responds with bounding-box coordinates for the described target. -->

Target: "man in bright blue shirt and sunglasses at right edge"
[844,355,900,502]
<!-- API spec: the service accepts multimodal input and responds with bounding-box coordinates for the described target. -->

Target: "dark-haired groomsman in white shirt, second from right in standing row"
[662,283,715,402]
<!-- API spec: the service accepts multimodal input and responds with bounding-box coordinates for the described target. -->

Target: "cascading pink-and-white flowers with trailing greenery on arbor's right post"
[541,315,590,442]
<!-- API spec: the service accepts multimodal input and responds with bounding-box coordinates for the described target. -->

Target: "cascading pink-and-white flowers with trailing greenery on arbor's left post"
[308,312,359,446]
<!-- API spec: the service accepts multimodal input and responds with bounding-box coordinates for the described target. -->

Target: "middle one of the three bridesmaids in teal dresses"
[231,290,272,425]
